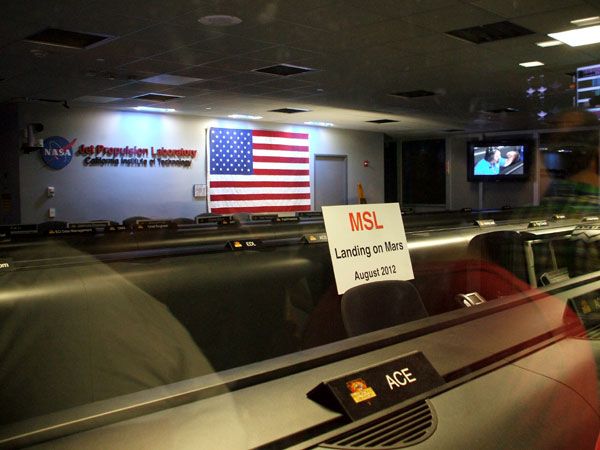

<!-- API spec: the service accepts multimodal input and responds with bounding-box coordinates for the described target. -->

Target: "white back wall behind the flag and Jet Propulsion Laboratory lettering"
[20,104,383,223]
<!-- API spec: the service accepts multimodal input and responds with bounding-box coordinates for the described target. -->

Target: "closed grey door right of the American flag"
[315,155,348,211]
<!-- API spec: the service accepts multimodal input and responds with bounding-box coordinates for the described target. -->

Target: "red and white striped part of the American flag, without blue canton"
[208,130,311,214]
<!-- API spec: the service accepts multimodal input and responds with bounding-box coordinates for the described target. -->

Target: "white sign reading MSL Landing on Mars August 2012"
[322,203,414,294]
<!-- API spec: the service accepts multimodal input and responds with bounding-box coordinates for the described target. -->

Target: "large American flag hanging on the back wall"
[208,128,311,214]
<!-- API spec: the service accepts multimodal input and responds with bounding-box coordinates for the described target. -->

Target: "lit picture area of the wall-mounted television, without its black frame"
[472,145,525,176]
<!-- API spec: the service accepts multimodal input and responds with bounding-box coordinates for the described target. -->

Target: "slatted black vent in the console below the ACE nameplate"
[319,401,437,450]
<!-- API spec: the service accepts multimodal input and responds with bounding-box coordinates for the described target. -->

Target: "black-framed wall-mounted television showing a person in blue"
[467,139,534,181]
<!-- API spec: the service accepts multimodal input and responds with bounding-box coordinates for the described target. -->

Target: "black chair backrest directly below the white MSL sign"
[341,280,428,336]
